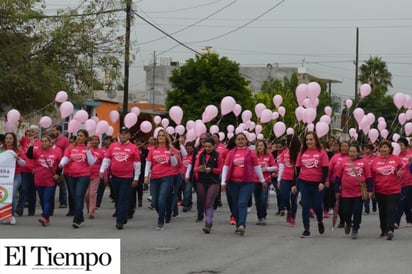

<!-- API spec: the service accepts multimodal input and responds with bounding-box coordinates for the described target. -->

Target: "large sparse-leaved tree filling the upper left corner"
[0,0,123,114]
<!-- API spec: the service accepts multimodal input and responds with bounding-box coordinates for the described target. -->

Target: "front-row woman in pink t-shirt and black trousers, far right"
[371,140,402,241]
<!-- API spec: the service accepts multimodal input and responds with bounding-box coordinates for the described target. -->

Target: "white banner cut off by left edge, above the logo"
[0,150,16,220]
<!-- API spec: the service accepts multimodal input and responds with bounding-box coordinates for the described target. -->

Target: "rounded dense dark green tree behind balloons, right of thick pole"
[166,54,253,129]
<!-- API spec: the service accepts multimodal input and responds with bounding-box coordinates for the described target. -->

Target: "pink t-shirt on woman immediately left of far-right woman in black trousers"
[335,157,371,198]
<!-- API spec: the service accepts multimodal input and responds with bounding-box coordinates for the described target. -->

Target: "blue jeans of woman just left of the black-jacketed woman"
[150,176,173,224]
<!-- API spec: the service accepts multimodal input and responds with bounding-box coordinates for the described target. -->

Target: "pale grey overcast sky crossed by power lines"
[46,0,412,98]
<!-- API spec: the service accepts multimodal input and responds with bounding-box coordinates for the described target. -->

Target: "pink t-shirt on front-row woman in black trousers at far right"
[371,154,402,195]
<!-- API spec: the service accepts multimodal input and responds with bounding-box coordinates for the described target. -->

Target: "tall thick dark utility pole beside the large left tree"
[120,0,132,119]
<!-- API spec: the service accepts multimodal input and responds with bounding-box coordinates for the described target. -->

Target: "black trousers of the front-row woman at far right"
[375,193,400,234]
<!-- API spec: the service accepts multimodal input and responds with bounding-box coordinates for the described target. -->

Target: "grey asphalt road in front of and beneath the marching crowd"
[0,193,412,274]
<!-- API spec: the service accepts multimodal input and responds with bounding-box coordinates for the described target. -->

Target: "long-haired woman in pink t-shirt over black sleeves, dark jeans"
[292,132,329,238]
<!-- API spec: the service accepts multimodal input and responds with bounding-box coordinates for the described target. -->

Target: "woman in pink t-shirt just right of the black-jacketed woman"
[221,133,267,236]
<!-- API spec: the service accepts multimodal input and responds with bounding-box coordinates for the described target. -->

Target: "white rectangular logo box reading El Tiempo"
[0,239,120,274]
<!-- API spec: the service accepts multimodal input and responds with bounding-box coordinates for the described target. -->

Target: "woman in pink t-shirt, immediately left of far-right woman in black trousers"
[334,144,373,239]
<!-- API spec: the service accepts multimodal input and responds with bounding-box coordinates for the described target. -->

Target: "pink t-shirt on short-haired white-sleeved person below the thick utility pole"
[105,142,140,178]
